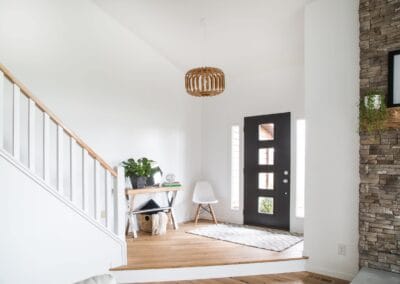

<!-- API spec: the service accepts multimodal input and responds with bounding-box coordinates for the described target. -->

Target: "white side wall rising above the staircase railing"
[0,0,201,221]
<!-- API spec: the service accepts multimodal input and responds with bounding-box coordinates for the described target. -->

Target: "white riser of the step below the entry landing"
[111,259,306,284]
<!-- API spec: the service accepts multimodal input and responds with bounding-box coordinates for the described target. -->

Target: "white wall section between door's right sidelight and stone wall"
[304,0,359,279]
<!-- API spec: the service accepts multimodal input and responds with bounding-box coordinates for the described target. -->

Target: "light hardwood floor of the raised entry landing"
[113,221,304,270]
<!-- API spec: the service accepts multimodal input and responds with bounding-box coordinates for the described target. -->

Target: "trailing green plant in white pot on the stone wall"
[360,90,388,133]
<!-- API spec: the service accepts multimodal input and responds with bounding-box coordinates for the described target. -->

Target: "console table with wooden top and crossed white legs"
[125,186,183,238]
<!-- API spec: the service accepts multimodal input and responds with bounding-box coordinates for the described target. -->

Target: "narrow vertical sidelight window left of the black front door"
[231,125,240,210]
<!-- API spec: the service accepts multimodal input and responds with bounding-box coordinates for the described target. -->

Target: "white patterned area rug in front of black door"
[187,224,303,252]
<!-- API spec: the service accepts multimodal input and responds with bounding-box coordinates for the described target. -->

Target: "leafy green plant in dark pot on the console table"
[122,158,153,188]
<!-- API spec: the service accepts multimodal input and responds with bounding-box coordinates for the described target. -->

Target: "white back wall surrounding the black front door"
[202,3,304,232]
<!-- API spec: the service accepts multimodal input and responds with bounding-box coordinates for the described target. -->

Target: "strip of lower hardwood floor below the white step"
[148,272,349,284]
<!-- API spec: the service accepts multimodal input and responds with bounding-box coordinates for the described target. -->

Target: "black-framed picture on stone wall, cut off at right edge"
[388,50,400,107]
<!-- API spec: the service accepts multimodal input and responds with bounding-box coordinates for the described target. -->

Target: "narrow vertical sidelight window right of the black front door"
[296,119,306,218]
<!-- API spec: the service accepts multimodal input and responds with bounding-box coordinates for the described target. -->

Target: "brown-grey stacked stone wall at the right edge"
[359,0,400,273]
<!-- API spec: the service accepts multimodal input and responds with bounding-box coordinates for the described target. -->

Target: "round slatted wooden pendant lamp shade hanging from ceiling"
[185,67,225,97]
